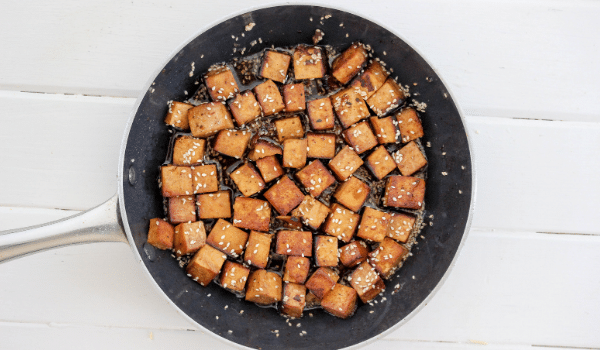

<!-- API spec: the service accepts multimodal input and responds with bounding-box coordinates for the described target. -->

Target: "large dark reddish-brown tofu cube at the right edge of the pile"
[382,175,425,209]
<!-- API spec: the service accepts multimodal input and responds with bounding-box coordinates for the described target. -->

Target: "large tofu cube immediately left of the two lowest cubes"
[246,270,283,305]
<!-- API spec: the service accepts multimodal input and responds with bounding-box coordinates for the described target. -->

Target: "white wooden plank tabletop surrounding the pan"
[0,0,600,349]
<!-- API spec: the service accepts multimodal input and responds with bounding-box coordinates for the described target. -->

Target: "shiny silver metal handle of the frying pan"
[0,194,127,263]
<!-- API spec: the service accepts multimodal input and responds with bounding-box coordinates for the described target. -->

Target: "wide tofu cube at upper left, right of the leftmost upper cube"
[188,102,233,138]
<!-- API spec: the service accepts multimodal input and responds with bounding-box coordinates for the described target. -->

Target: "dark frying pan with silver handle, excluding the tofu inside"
[0,5,475,349]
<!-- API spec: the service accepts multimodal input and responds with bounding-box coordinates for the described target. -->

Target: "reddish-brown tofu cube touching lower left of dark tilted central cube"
[233,197,271,232]
